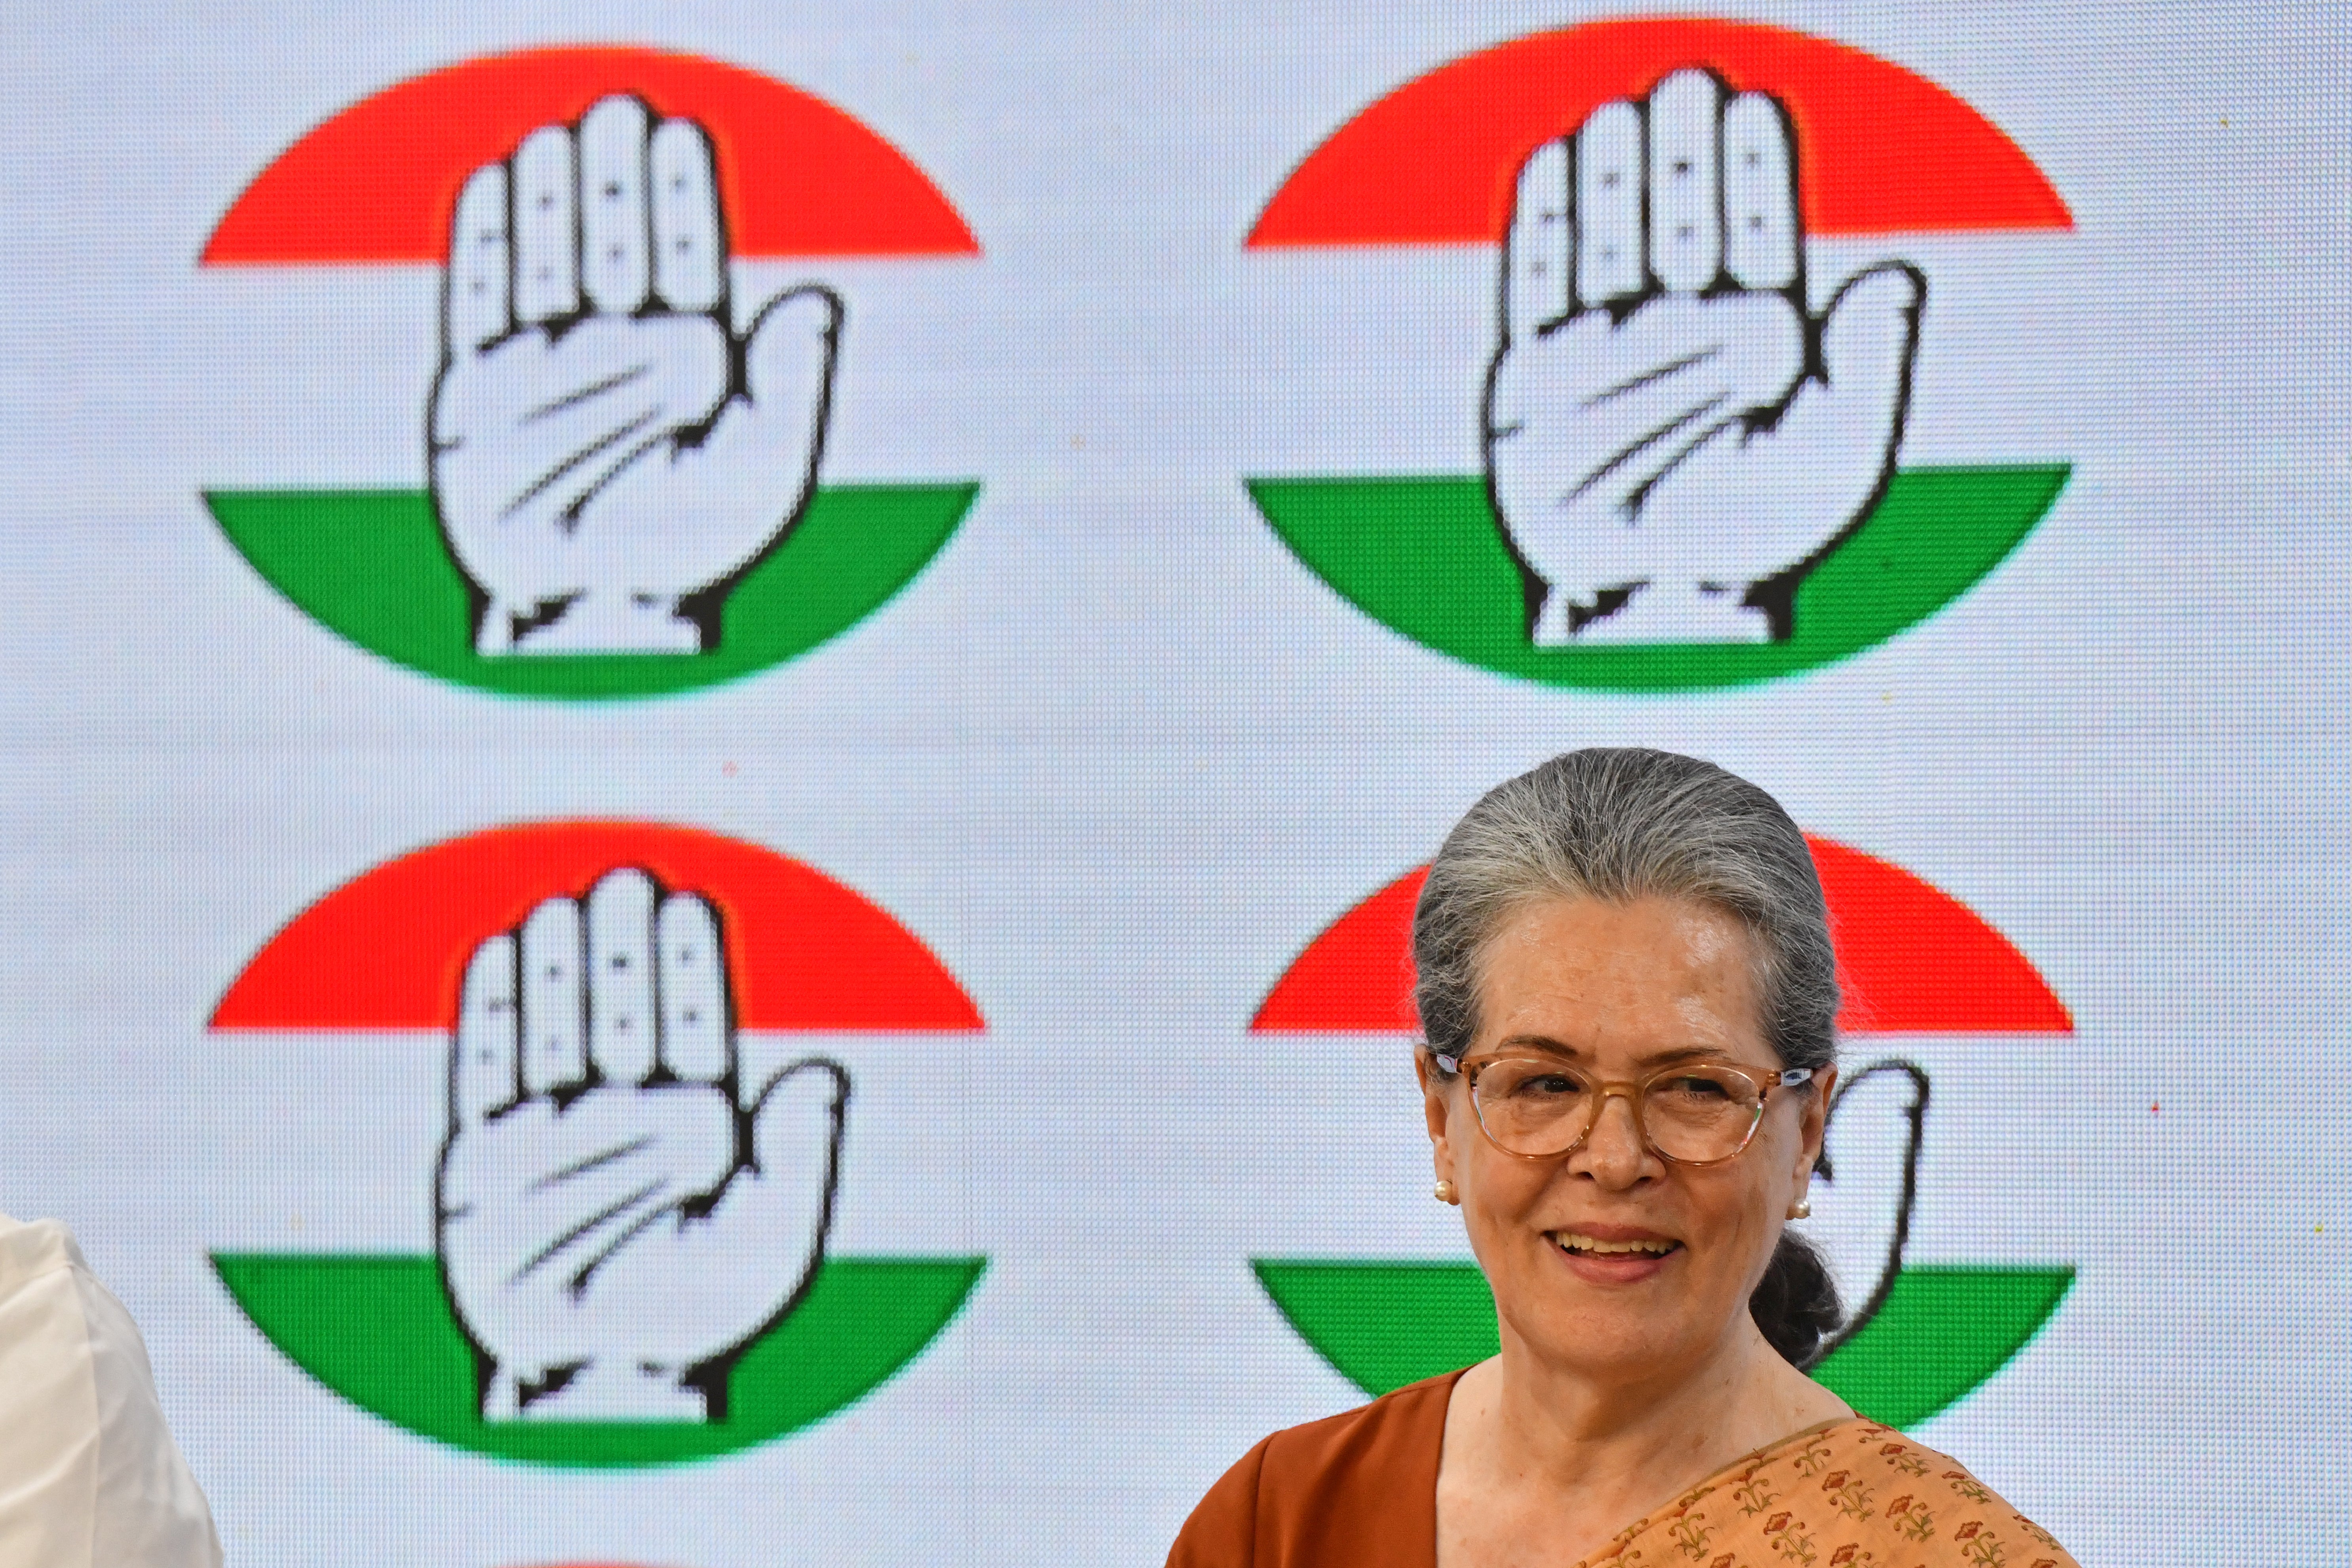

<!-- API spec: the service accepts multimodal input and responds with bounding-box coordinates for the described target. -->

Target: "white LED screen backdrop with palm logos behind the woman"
[0,2,2352,1568]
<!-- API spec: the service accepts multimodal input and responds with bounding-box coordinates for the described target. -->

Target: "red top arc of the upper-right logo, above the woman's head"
[1246,17,2075,249]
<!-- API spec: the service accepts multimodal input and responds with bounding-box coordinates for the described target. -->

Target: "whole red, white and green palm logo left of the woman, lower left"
[212,823,983,1467]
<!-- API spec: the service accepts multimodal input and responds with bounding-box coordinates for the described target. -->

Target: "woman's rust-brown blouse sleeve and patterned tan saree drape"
[1169,1373,2077,1568]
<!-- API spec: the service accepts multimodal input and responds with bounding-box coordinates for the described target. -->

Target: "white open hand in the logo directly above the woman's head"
[1487,70,1926,647]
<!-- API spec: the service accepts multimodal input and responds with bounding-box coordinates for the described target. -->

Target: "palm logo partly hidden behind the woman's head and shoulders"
[1249,839,2075,1427]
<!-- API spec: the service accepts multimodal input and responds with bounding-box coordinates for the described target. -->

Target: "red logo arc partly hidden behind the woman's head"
[1249,837,2075,1034]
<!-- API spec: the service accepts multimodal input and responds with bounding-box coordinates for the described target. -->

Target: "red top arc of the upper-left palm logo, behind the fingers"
[202,47,981,265]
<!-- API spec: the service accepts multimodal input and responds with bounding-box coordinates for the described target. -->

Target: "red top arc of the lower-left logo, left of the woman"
[212,821,983,1032]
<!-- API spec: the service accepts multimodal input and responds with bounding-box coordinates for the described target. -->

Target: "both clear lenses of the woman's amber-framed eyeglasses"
[1472,1058,1764,1164]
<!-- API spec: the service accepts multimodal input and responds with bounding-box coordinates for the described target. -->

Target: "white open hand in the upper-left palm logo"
[428,99,842,654]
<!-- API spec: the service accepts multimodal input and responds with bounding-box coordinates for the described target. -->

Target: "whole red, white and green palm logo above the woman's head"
[1249,19,2070,691]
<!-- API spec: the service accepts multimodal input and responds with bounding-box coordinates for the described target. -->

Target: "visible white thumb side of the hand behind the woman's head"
[1802,1058,1929,1354]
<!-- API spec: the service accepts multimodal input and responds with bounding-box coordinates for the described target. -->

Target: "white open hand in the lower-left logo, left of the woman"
[435,867,849,1420]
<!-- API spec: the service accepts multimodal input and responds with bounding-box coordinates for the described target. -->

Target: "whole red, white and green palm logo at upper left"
[205,49,976,698]
